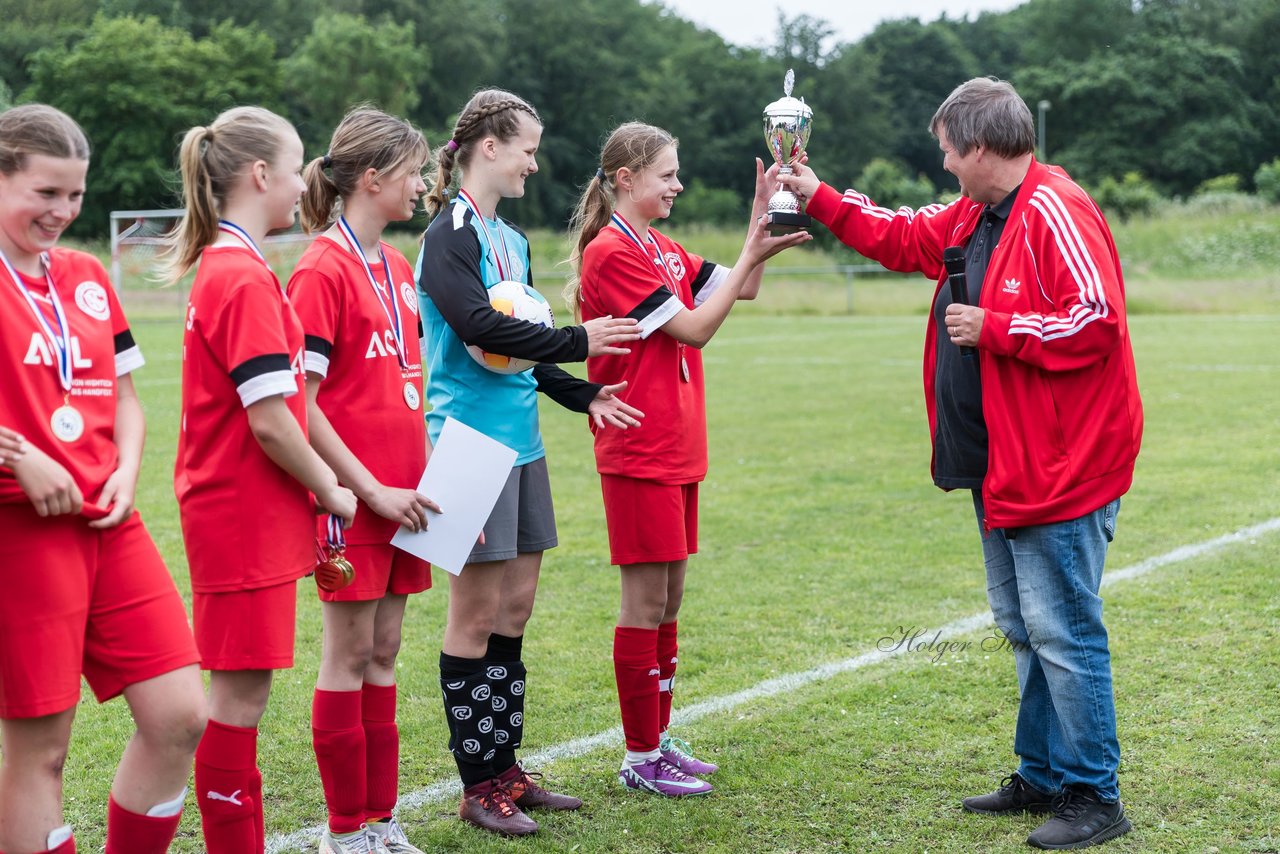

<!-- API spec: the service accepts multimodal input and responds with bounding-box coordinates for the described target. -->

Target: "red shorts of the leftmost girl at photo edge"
[0,503,200,718]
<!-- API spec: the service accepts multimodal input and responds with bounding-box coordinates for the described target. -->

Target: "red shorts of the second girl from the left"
[191,581,298,670]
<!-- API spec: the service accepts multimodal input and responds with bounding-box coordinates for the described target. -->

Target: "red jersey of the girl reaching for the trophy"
[582,225,727,484]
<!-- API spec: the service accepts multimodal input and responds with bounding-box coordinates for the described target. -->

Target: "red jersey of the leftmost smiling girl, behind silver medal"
[0,248,142,512]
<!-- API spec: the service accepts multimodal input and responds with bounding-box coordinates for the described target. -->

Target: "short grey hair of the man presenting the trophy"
[929,77,1036,159]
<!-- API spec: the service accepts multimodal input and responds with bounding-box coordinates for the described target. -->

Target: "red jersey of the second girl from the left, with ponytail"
[174,246,316,593]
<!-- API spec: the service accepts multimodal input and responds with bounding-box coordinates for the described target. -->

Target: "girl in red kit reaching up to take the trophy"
[566,123,809,796]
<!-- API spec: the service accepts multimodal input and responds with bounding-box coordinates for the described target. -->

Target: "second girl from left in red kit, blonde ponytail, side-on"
[169,106,356,854]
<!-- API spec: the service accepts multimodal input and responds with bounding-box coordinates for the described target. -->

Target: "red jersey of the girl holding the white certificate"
[288,237,426,544]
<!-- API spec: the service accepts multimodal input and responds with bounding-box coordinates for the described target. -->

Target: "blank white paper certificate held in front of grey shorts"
[392,419,517,575]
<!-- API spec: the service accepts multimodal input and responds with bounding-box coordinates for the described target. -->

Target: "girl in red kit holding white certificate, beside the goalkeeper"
[288,108,439,854]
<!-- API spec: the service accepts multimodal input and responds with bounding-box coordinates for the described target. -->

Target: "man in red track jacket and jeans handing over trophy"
[786,78,1142,849]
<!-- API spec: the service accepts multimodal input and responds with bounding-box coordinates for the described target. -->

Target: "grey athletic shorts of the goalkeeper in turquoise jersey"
[467,457,559,563]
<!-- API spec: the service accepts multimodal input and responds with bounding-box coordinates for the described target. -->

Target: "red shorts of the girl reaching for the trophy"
[600,475,698,566]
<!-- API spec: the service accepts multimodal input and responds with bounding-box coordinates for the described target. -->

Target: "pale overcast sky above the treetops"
[660,0,1025,47]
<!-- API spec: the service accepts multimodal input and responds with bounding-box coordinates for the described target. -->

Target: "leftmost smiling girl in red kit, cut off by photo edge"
[0,104,205,854]
